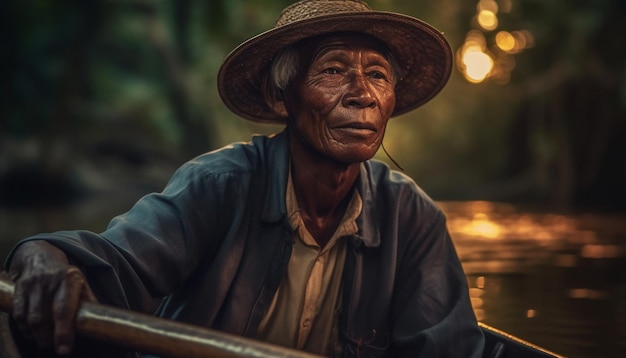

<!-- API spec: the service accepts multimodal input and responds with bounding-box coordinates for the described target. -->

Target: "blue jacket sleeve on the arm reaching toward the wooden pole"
[6,162,225,312]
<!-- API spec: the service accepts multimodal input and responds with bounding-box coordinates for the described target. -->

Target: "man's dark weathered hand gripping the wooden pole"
[9,241,96,355]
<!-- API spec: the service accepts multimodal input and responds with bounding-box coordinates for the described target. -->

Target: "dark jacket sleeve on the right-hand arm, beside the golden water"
[392,200,484,358]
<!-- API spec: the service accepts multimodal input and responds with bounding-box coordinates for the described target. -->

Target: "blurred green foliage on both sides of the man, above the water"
[0,0,626,208]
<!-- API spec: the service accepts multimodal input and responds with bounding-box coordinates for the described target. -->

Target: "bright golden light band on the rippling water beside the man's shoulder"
[439,201,626,273]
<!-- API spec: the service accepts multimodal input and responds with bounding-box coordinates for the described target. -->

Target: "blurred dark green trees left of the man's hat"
[0,0,284,204]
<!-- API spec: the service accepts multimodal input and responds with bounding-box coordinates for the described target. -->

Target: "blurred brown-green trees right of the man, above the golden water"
[381,0,626,209]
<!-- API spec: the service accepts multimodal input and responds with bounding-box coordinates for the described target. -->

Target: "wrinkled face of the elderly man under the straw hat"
[285,34,396,164]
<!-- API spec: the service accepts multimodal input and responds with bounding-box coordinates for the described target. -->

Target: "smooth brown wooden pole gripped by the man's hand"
[0,273,319,358]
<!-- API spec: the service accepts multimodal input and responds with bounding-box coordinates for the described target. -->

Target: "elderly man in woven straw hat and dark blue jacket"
[7,0,483,357]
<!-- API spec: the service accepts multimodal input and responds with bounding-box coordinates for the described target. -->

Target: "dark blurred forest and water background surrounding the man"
[0,0,626,357]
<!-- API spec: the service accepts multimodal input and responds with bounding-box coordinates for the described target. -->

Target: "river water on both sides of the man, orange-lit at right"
[0,200,626,357]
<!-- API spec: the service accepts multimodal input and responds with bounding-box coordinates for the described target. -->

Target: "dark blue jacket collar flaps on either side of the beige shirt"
[253,130,380,247]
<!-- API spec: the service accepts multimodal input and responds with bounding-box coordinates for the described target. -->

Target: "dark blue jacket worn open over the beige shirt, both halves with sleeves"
[8,132,483,358]
